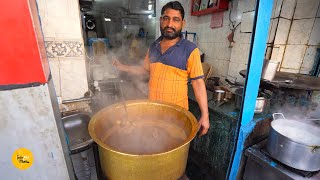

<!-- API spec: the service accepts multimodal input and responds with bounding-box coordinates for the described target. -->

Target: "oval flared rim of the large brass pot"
[88,99,200,157]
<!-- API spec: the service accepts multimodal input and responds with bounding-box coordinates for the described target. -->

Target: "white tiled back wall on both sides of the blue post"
[156,0,320,81]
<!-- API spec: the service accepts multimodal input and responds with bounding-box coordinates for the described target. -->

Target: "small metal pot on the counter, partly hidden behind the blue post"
[234,88,270,114]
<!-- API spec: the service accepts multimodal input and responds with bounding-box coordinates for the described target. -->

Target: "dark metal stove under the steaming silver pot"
[243,140,320,180]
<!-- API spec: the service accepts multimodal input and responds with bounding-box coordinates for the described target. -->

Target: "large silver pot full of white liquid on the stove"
[267,113,320,171]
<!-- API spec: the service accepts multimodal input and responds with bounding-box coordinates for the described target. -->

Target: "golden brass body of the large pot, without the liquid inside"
[89,100,199,180]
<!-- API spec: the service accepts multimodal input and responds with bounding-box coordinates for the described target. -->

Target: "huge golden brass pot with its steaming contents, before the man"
[89,100,199,180]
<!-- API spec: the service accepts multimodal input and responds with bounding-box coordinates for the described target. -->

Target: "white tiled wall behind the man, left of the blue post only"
[156,0,255,81]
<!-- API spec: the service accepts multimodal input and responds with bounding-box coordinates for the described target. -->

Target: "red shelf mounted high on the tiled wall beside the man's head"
[191,0,229,16]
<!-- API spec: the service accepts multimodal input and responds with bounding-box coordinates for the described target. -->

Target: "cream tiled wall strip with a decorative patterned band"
[37,0,88,100]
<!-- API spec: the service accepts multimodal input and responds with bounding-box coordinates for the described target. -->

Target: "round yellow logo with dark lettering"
[11,148,33,170]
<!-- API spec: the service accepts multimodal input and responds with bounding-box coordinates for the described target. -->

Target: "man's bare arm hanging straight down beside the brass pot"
[191,79,210,136]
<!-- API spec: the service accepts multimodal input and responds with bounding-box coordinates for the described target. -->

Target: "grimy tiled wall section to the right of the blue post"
[266,0,320,74]
